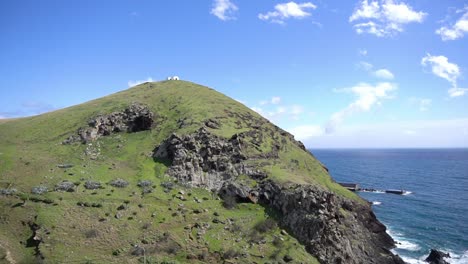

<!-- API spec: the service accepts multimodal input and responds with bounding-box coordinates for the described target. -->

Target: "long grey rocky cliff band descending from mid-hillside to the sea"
[153,128,403,264]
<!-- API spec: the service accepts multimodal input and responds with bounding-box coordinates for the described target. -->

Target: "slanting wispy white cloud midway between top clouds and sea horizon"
[325,82,397,133]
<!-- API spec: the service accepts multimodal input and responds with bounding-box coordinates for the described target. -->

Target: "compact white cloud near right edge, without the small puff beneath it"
[421,54,461,87]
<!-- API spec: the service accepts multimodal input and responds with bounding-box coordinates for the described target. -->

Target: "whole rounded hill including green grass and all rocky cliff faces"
[0,81,401,263]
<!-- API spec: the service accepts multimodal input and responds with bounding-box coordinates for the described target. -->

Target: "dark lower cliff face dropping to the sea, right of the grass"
[259,181,404,264]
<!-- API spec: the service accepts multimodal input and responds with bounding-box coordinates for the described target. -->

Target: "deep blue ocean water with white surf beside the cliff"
[311,149,468,264]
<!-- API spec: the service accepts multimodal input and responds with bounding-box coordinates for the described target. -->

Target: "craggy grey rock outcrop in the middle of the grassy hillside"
[153,128,261,190]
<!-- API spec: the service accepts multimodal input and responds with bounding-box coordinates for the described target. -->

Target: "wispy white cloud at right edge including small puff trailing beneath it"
[421,54,468,97]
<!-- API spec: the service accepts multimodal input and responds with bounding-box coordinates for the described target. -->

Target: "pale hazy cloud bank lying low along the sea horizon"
[300,118,468,148]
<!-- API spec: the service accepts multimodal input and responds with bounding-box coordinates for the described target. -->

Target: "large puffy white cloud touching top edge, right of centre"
[349,0,427,37]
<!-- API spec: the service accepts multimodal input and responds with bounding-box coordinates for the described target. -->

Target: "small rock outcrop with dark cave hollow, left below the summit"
[63,103,154,144]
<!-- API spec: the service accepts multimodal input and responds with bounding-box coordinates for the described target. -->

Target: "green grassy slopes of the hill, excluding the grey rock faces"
[0,81,360,263]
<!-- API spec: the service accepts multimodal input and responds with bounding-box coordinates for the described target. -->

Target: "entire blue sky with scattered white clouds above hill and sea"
[0,0,468,148]
